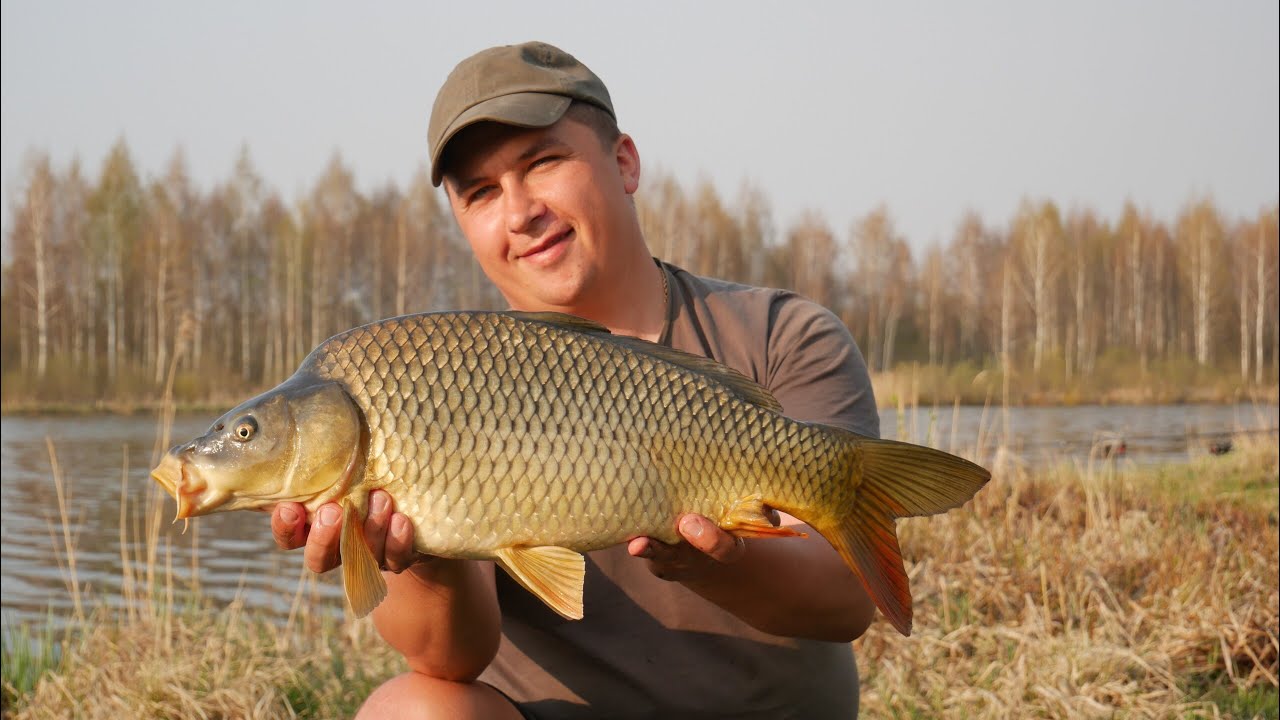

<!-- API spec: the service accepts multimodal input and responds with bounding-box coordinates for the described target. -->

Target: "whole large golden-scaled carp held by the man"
[151,311,991,634]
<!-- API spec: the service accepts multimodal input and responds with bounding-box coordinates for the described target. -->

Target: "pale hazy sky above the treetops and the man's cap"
[0,0,1280,250]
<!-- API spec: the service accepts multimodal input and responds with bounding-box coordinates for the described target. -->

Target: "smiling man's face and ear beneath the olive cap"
[444,118,643,311]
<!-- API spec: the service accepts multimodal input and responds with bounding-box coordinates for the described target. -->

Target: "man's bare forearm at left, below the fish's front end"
[372,559,502,682]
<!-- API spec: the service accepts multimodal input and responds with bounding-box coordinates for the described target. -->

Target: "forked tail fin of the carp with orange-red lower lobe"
[814,433,991,635]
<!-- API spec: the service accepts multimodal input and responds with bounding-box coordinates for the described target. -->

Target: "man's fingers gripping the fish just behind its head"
[271,489,428,573]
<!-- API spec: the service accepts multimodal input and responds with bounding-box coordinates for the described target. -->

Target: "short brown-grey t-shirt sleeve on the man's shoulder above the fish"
[765,295,879,437]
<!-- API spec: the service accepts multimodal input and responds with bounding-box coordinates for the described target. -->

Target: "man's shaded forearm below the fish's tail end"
[684,525,876,642]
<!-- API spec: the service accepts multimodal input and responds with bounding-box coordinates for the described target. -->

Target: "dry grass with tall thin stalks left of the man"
[3,425,404,720]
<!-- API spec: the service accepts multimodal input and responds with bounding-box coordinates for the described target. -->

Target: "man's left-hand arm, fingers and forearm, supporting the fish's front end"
[271,491,502,682]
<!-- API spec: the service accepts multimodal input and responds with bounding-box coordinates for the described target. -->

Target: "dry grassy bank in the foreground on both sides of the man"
[3,425,1280,720]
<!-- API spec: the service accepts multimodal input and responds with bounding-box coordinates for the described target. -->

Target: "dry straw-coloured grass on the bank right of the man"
[856,430,1280,717]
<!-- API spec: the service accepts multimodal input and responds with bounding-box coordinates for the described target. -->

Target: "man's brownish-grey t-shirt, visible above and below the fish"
[480,264,879,720]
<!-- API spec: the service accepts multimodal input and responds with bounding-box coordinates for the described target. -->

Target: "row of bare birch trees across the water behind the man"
[0,141,1280,410]
